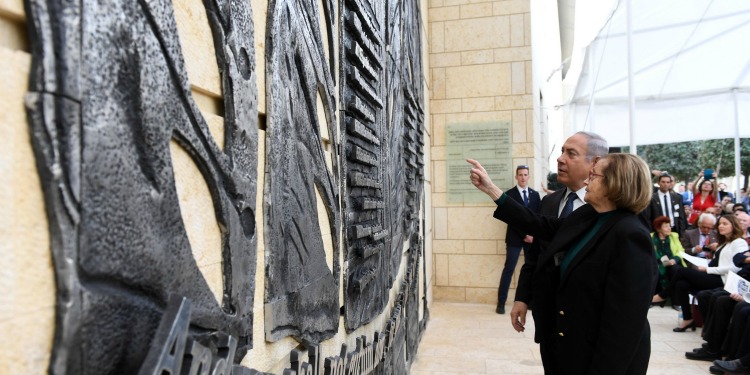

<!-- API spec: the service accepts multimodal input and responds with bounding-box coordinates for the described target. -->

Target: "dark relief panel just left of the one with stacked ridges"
[264,0,341,342]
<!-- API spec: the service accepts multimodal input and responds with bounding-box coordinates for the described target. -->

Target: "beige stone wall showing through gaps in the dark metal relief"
[0,0,434,374]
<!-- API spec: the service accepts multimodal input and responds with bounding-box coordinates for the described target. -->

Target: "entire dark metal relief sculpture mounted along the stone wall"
[14,0,429,374]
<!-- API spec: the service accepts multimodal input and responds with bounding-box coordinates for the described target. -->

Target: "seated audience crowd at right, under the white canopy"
[641,170,750,374]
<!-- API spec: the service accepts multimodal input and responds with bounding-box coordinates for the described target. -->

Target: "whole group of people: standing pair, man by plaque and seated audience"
[467,132,750,375]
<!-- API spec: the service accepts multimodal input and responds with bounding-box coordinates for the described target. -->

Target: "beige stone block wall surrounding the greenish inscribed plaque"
[428,0,540,303]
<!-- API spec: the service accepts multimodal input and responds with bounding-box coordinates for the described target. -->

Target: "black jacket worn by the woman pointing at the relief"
[494,195,657,375]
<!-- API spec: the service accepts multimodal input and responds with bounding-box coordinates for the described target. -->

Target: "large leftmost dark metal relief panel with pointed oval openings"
[26,0,257,374]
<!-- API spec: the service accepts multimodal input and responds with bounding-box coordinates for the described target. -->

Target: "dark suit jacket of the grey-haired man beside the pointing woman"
[515,189,567,306]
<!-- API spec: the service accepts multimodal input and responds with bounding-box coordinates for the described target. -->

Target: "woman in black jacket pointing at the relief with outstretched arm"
[467,154,657,375]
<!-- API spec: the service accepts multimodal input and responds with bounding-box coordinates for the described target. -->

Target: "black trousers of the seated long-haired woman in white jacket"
[659,268,724,320]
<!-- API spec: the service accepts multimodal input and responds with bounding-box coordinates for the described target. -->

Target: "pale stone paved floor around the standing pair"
[411,302,711,375]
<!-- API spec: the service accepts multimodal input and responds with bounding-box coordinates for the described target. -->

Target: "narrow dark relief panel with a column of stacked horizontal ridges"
[340,0,391,331]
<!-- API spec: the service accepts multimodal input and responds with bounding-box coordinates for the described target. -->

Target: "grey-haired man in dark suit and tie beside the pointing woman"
[510,132,609,369]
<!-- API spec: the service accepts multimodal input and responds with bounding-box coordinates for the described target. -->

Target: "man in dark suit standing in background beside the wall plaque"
[495,165,541,314]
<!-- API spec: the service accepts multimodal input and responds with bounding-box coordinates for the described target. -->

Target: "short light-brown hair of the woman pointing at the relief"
[601,153,653,214]
